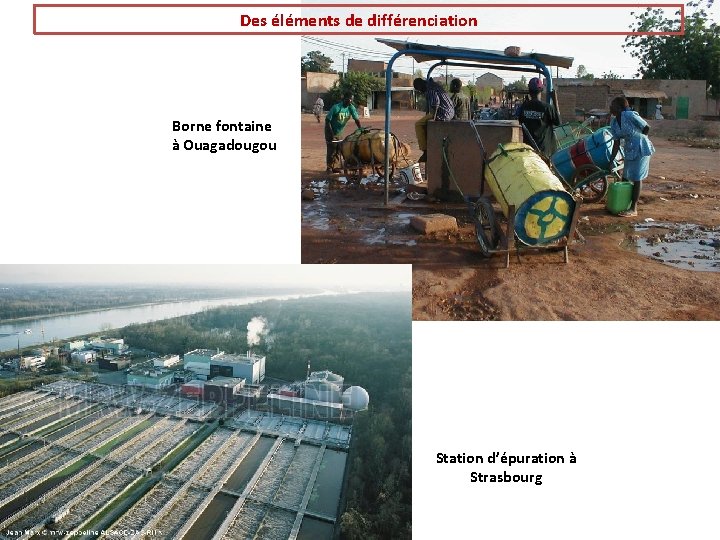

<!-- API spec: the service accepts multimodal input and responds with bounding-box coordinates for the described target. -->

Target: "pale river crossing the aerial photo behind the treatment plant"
[0,292,326,352]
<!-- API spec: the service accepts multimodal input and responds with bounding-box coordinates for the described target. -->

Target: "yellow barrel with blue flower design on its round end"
[485,143,576,246]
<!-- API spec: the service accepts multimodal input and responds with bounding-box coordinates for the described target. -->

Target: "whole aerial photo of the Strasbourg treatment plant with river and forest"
[0,266,411,539]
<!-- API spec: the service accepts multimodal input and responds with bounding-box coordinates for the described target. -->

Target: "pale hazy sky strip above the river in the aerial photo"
[0,264,412,291]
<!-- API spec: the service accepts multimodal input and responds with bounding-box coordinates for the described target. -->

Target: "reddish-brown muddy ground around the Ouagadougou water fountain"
[301,111,720,320]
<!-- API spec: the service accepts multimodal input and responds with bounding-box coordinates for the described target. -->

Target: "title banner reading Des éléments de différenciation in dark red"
[33,4,684,36]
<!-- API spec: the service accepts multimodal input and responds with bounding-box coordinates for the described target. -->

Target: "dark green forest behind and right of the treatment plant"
[117,293,412,540]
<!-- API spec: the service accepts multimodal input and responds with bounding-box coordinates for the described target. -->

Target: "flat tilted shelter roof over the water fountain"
[376,38,574,68]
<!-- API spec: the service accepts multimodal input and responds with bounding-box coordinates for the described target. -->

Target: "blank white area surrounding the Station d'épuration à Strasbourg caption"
[413,322,720,540]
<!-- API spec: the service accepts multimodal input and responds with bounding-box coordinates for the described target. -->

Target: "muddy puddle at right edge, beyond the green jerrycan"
[629,222,720,272]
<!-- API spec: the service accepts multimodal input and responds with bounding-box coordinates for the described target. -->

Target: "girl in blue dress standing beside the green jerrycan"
[610,96,655,217]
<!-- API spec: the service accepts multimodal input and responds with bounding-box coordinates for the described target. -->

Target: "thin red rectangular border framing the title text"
[33,4,685,36]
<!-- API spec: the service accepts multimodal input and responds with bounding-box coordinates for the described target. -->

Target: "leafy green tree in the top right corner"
[623,0,720,98]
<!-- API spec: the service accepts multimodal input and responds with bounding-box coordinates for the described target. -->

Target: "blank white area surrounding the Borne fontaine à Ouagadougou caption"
[0,1,300,263]
